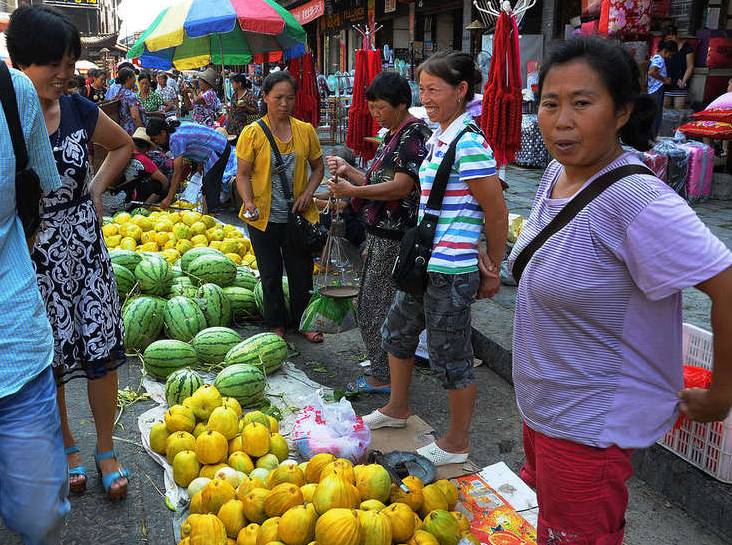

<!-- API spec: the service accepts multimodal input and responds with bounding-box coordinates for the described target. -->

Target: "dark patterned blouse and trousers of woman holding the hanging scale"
[352,121,430,383]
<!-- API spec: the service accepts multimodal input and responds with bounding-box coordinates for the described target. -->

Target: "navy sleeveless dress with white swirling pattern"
[31,94,124,384]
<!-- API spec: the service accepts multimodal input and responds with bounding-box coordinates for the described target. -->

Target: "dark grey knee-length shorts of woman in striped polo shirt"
[381,271,480,390]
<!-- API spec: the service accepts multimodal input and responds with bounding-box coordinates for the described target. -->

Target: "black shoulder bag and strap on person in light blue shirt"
[0,63,43,247]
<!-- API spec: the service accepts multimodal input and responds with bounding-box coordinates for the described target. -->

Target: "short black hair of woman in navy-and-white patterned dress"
[5,6,81,68]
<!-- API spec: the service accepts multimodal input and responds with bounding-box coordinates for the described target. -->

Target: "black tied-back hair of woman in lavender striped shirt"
[539,36,656,151]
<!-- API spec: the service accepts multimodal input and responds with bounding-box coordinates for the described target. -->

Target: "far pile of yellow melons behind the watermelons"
[102,205,257,269]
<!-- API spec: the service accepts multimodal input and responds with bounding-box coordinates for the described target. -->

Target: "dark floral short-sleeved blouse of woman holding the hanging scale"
[352,119,431,235]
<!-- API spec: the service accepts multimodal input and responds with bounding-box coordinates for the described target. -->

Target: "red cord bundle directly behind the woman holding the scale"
[346,49,381,161]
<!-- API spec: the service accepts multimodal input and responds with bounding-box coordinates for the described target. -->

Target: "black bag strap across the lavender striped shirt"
[511,165,655,283]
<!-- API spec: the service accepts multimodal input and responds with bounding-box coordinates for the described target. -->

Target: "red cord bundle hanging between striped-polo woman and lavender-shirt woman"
[480,12,522,166]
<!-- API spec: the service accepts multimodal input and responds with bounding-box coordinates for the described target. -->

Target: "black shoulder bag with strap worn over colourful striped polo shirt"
[391,125,479,296]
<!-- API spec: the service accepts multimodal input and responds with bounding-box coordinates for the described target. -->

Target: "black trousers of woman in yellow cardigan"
[249,223,313,327]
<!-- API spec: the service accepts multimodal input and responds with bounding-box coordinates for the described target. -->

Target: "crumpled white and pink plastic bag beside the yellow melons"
[292,393,371,462]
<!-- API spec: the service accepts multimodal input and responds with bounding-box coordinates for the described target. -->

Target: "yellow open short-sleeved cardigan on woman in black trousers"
[236,117,323,231]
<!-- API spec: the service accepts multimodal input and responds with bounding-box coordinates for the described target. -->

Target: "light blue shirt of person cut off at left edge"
[0,68,61,398]
